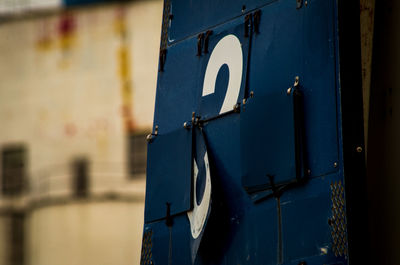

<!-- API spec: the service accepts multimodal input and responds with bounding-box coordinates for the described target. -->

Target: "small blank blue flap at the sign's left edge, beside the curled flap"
[145,128,193,222]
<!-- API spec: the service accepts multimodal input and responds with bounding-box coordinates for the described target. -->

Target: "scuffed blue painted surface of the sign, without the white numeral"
[144,0,354,265]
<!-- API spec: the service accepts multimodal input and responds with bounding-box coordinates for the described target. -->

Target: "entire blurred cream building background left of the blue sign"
[0,0,162,265]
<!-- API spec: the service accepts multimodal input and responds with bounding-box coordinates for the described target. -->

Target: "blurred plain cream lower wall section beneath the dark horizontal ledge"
[27,202,143,265]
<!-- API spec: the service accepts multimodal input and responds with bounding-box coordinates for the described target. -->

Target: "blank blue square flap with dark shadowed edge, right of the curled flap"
[240,89,300,191]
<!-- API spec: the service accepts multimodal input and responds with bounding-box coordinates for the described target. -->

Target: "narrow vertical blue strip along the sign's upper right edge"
[302,0,340,176]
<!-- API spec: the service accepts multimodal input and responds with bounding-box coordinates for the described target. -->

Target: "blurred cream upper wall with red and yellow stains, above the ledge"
[0,1,162,194]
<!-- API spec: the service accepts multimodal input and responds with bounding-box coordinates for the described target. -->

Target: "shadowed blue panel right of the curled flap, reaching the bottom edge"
[197,114,278,265]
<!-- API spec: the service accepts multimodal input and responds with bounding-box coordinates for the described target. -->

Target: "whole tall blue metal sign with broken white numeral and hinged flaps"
[142,0,368,265]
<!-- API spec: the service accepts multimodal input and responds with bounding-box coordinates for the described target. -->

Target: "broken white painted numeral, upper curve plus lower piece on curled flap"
[187,34,243,239]
